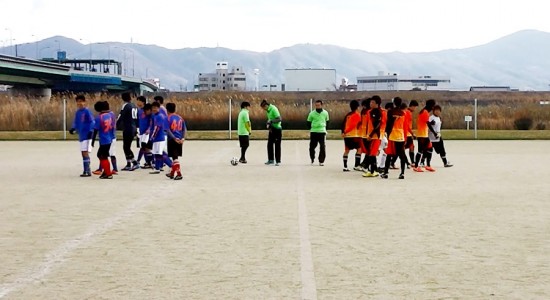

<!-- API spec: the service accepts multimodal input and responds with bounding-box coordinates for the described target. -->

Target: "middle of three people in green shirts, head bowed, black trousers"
[260,99,283,166]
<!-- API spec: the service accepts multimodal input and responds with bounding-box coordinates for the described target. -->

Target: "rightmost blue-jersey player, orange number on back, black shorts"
[166,103,187,180]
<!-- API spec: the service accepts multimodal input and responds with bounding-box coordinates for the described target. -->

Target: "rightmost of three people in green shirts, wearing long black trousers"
[307,100,329,166]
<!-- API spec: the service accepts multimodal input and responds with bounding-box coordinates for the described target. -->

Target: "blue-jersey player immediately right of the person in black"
[137,96,153,169]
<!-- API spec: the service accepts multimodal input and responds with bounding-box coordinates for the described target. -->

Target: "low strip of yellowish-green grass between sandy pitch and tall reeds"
[0,130,550,141]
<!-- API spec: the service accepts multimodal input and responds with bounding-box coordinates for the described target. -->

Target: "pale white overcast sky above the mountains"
[0,0,550,52]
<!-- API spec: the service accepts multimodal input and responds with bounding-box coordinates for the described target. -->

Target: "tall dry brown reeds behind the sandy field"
[0,92,550,131]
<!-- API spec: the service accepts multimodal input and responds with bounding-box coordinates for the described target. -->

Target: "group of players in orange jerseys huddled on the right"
[342,95,452,179]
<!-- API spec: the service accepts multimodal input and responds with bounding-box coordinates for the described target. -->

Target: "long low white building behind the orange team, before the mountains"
[357,72,451,91]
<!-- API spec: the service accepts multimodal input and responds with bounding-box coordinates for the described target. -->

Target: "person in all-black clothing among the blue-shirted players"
[117,93,139,171]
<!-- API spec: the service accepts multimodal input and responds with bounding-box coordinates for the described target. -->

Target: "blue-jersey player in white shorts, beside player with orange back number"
[149,101,179,174]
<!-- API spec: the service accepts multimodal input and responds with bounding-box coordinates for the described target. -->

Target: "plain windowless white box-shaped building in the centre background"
[284,68,337,92]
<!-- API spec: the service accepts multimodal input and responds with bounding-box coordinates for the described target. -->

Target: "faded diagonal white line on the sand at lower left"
[0,185,173,298]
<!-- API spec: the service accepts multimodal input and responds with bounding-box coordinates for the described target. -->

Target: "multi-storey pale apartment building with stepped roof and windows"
[198,62,246,91]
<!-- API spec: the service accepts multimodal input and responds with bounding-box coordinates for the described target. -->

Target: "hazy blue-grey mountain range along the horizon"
[0,30,550,91]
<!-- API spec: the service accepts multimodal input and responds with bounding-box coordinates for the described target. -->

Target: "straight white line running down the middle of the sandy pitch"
[295,142,317,300]
